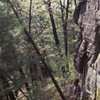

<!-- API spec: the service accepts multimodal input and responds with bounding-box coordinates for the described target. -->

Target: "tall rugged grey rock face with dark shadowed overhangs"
[74,0,100,100]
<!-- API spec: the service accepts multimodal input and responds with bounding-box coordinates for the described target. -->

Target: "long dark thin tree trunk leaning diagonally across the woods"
[7,0,65,100]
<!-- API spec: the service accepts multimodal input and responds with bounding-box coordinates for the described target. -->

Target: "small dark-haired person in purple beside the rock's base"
[74,79,80,100]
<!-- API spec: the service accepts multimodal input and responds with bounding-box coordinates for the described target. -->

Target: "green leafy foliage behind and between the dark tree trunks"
[0,0,79,100]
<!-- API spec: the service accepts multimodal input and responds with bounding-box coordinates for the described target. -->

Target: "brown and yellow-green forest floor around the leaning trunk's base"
[17,78,73,100]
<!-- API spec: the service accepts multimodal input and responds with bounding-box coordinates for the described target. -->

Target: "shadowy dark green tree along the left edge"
[0,3,28,100]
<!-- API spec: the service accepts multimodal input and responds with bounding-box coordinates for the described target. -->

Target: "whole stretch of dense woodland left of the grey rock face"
[0,0,79,100]
